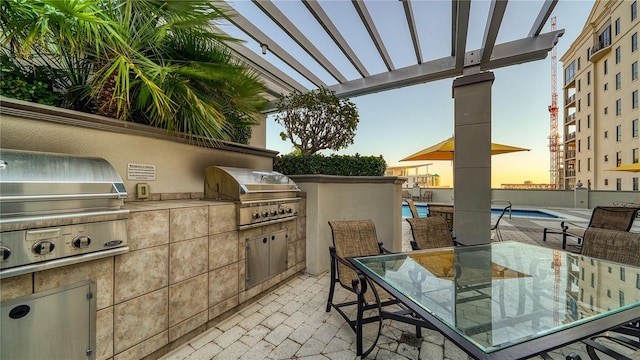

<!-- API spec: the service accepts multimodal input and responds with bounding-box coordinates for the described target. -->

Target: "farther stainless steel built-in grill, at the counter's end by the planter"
[204,166,300,229]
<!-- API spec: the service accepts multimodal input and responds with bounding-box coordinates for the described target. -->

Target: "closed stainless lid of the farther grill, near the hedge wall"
[204,166,300,201]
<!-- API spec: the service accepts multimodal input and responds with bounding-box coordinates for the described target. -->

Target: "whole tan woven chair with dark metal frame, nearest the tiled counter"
[326,220,421,358]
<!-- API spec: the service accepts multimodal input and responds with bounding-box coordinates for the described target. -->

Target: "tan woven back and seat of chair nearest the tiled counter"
[329,220,380,300]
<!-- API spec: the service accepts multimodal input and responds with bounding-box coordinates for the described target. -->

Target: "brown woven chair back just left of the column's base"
[407,216,456,250]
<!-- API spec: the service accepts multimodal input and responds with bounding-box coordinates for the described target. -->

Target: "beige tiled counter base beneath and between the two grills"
[0,198,306,360]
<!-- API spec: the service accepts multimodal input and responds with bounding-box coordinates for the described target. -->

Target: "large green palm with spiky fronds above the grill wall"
[0,0,264,142]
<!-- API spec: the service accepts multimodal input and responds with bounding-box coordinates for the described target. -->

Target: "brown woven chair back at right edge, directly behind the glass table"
[580,227,640,266]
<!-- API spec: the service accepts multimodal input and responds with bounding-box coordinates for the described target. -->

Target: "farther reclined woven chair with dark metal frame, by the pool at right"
[542,206,640,249]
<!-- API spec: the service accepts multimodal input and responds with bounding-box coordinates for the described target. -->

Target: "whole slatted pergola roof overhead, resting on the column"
[219,0,564,112]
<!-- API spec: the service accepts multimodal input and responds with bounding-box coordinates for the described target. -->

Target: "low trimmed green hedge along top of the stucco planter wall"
[273,154,387,176]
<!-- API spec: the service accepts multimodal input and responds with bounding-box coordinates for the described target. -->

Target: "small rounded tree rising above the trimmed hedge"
[275,88,359,155]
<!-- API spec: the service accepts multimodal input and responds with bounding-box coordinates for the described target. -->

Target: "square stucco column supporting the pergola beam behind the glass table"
[453,72,495,245]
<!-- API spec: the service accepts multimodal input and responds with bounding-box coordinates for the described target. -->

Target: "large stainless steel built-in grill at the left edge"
[0,149,129,279]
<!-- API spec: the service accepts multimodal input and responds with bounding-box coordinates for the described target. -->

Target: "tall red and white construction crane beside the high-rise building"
[549,16,561,189]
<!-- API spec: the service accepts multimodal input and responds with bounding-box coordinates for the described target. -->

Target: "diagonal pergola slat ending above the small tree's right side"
[253,0,347,83]
